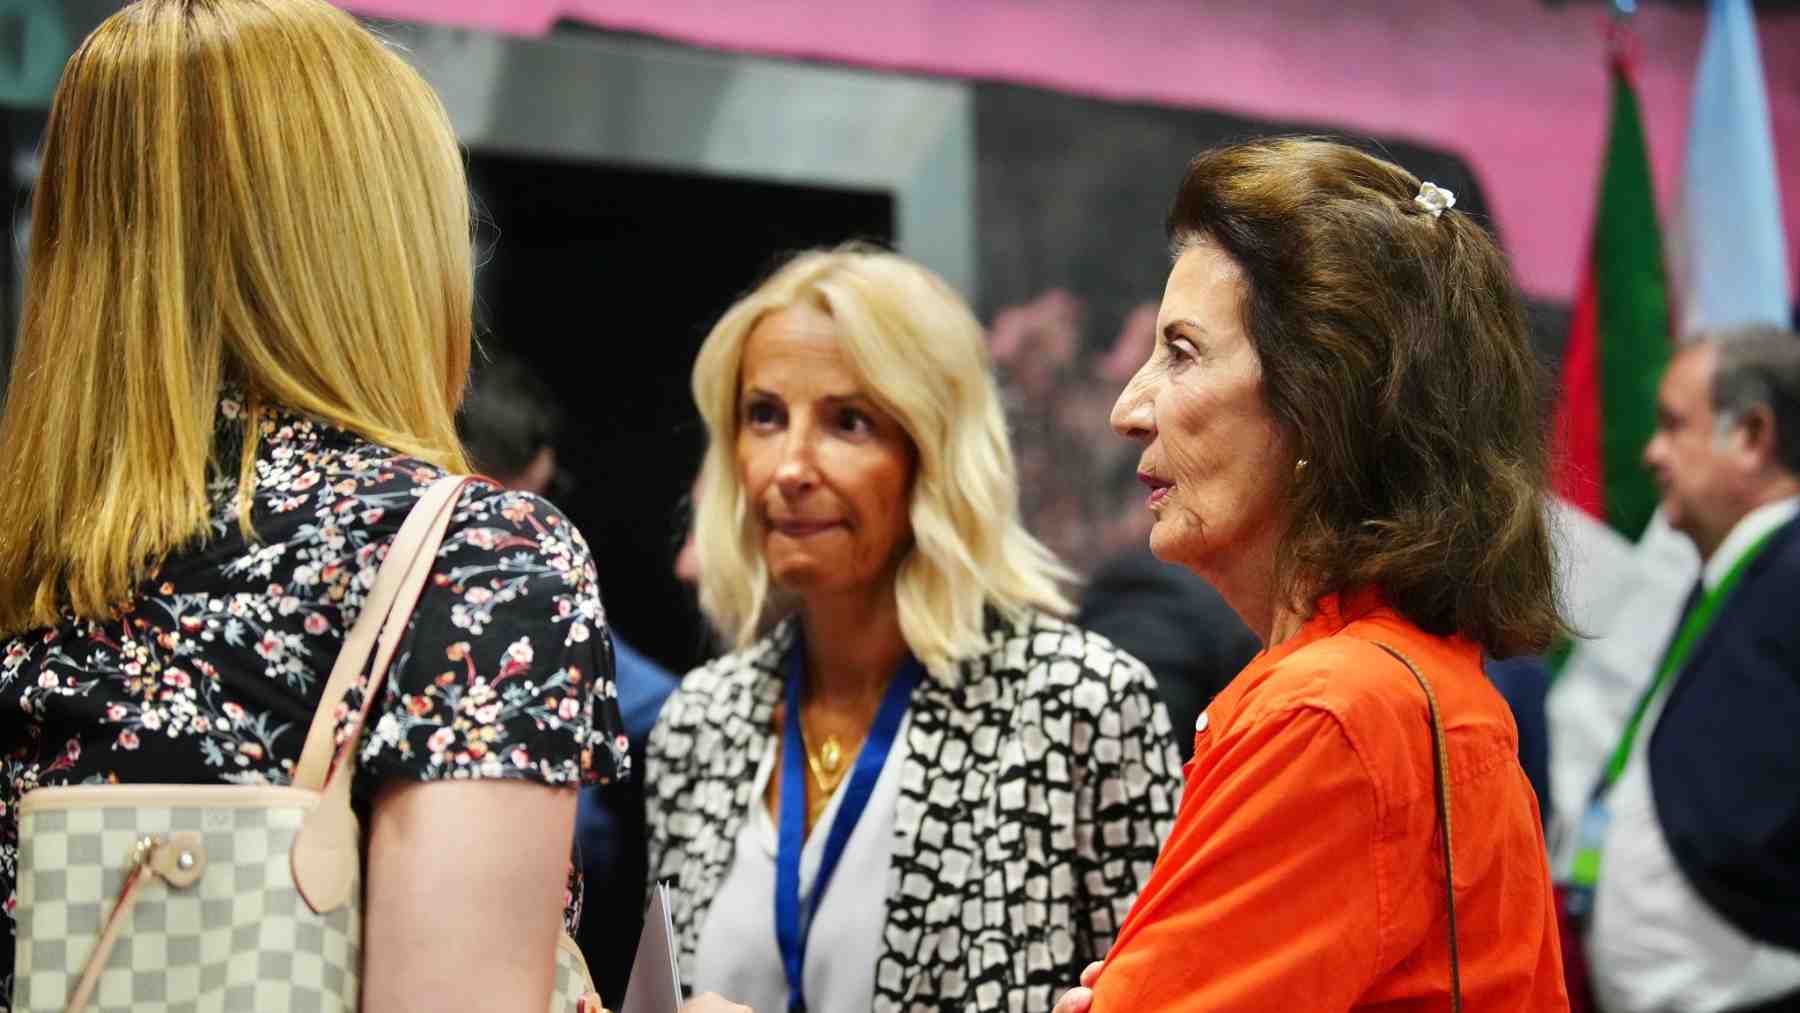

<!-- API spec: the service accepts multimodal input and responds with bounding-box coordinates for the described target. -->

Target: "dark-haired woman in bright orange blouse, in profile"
[1057,140,1568,1013]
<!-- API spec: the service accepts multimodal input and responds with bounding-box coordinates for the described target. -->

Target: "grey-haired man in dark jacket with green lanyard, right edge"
[1573,327,1800,1013]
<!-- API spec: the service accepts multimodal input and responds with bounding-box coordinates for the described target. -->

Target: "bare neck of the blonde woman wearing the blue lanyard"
[799,583,907,716]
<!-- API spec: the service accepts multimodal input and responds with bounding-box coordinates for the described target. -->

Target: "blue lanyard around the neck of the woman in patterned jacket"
[776,633,923,1013]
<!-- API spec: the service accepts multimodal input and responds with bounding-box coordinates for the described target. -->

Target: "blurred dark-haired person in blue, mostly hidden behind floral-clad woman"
[457,356,675,1006]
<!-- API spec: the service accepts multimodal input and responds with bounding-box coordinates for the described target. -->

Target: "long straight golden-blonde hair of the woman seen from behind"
[0,0,473,632]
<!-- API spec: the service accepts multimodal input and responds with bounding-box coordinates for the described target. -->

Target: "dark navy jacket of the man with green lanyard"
[1649,520,1800,950]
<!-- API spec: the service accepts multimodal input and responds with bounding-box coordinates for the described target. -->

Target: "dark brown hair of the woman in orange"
[1168,139,1564,657]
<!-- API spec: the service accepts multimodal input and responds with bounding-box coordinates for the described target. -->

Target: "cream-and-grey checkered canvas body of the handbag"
[13,806,362,1013]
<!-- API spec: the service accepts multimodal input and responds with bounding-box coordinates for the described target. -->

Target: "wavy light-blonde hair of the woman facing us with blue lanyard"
[693,245,1071,671]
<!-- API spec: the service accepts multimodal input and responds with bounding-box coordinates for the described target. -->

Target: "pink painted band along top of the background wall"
[338,0,1800,299]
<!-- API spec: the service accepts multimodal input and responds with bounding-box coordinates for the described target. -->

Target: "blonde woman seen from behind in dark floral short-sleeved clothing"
[0,0,745,1013]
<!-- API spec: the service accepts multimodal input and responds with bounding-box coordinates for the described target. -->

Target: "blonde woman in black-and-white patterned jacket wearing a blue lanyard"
[646,248,1179,1013]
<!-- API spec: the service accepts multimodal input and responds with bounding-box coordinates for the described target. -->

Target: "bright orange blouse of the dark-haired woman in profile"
[1093,590,1568,1013]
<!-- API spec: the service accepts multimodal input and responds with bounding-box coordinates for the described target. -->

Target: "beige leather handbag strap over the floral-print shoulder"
[288,475,472,914]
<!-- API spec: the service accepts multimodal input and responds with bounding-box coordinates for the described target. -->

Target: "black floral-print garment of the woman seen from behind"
[0,392,630,1011]
